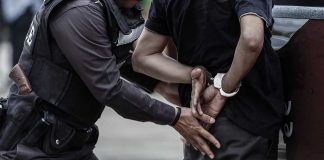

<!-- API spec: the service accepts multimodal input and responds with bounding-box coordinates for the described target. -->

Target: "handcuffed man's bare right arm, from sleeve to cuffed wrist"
[222,14,264,93]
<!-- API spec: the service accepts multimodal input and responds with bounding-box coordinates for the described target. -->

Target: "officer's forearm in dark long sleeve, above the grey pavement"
[106,81,176,125]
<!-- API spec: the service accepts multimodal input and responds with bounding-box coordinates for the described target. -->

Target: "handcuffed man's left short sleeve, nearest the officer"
[145,0,170,35]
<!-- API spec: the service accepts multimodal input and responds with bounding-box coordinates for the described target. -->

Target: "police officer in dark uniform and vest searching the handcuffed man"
[0,0,219,160]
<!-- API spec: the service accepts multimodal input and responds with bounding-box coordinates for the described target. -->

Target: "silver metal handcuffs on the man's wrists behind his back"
[194,66,241,98]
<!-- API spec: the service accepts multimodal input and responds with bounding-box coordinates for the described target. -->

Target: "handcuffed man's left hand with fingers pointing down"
[190,66,215,121]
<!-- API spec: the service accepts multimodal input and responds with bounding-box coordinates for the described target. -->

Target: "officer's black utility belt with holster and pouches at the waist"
[0,89,99,155]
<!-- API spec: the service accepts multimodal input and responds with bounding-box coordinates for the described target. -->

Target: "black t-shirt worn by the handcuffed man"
[146,0,284,137]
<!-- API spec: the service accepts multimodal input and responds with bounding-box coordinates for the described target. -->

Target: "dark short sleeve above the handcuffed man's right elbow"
[235,0,273,28]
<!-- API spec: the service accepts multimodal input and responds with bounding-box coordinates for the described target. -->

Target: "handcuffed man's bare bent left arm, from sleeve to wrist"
[132,28,192,83]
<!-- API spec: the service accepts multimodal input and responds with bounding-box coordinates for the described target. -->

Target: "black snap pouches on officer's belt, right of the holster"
[33,111,99,155]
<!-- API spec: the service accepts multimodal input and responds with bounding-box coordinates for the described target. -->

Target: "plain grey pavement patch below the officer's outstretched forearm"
[95,102,182,160]
